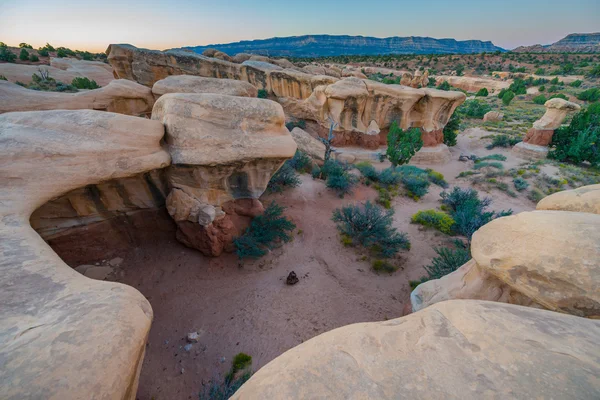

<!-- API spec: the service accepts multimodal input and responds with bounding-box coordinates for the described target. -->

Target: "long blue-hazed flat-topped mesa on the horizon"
[179,35,504,57]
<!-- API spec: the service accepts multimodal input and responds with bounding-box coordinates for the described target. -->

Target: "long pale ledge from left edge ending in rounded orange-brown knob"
[0,79,154,116]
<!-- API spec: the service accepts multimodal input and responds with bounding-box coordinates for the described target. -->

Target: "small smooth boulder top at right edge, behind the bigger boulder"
[536,184,600,214]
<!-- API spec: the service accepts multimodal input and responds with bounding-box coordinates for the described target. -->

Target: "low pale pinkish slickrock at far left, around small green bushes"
[0,58,114,86]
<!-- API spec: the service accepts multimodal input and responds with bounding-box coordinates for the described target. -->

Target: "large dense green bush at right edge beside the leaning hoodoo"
[548,103,600,167]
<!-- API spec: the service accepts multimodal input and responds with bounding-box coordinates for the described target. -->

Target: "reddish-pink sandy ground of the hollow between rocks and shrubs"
[91,129,534,400]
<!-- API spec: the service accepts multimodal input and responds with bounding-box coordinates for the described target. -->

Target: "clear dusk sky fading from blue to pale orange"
[0,0,600,52]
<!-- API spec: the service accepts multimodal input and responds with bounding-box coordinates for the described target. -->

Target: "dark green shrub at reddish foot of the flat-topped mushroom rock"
[233,202,296,259]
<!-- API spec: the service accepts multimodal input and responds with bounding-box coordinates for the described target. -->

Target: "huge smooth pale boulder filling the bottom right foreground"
[232,300,600,400]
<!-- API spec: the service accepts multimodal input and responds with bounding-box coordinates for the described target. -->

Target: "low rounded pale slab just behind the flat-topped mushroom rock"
[152,75,258,99]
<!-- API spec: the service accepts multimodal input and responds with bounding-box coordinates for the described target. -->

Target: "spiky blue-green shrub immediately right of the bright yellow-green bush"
[440,186,512,240]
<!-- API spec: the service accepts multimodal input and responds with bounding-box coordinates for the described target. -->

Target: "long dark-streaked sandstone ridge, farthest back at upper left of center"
[106,44,337,99]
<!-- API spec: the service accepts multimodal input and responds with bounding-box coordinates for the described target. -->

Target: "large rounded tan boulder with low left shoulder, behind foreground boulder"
[411,208,600,318]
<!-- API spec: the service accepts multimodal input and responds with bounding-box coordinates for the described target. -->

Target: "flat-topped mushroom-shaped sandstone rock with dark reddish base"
[152,93,297,256]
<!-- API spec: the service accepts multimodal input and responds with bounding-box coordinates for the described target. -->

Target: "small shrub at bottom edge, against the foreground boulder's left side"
[199,353,252,400]
